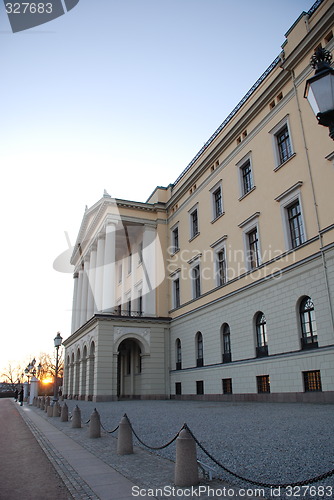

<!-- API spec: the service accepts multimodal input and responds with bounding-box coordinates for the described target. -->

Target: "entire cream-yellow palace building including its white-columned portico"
[63,0,334,402]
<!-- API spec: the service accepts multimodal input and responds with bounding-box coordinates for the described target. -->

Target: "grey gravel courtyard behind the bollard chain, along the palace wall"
[59,400,334,499]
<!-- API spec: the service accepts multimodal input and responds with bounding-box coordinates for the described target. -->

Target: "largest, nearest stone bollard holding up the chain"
[175,429,199,486]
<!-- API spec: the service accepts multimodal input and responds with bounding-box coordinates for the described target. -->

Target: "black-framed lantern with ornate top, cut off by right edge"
[304,48,334,140]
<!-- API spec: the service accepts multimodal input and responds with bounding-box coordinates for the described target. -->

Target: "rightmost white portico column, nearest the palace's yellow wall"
[142,225,156,316]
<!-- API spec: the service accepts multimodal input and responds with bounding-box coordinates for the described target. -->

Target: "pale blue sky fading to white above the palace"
[0,0,314,374]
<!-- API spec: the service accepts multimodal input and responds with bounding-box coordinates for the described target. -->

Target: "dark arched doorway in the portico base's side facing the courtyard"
[117,339,142,398]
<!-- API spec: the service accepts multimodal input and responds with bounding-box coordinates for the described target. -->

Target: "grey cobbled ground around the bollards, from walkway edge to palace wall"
[17,400,334,500]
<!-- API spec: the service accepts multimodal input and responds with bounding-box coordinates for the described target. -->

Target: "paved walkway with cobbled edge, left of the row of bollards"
[0,400,256,500]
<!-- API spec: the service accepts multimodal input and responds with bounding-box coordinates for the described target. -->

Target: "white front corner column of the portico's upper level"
[102,221,116,312]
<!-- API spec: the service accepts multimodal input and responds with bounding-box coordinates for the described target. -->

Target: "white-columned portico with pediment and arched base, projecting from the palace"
[64,193,169,401]
